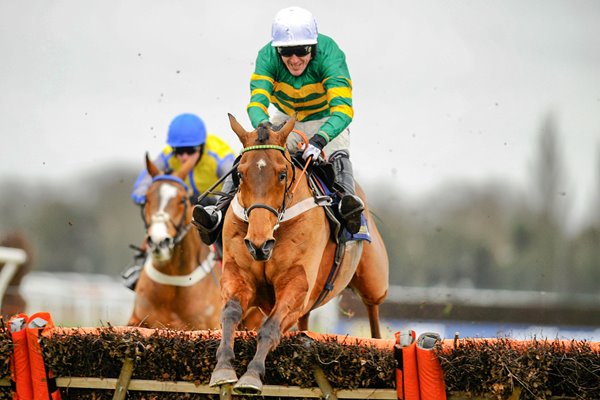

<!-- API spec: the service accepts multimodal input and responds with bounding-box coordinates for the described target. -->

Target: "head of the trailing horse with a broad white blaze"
[143,153,198,263]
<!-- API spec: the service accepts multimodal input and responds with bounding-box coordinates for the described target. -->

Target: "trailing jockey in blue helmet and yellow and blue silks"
[123,114,236,290]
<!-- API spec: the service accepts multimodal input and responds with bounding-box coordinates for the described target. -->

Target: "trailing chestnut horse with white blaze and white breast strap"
[127,153,221,330]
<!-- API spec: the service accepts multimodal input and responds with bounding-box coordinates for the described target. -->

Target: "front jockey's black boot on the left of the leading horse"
[192,175,237,245]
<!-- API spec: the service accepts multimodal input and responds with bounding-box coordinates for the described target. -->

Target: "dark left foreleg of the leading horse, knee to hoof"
[209,299,243,386]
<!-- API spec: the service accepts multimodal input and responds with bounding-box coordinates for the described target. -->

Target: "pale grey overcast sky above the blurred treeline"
[0,0,600,230]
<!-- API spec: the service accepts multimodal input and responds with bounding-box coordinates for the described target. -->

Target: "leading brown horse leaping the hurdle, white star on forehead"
[209,114,389,394]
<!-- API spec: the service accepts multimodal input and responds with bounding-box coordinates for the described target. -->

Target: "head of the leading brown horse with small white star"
[229,114,296,261]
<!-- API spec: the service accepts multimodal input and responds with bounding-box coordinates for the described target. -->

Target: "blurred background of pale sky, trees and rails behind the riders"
[0,0,600,340]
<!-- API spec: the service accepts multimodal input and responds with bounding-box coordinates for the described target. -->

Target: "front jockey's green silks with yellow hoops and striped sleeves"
[248,34,354,143]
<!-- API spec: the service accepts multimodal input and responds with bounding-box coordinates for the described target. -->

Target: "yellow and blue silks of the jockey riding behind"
[131,134,236,204]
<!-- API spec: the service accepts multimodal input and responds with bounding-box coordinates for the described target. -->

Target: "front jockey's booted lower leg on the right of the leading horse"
[330,151,365,234]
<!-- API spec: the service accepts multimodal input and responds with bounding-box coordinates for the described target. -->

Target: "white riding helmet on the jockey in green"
[271,7,319,47]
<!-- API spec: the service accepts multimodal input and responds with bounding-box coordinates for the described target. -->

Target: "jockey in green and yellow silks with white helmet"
[194,7,364,243]
